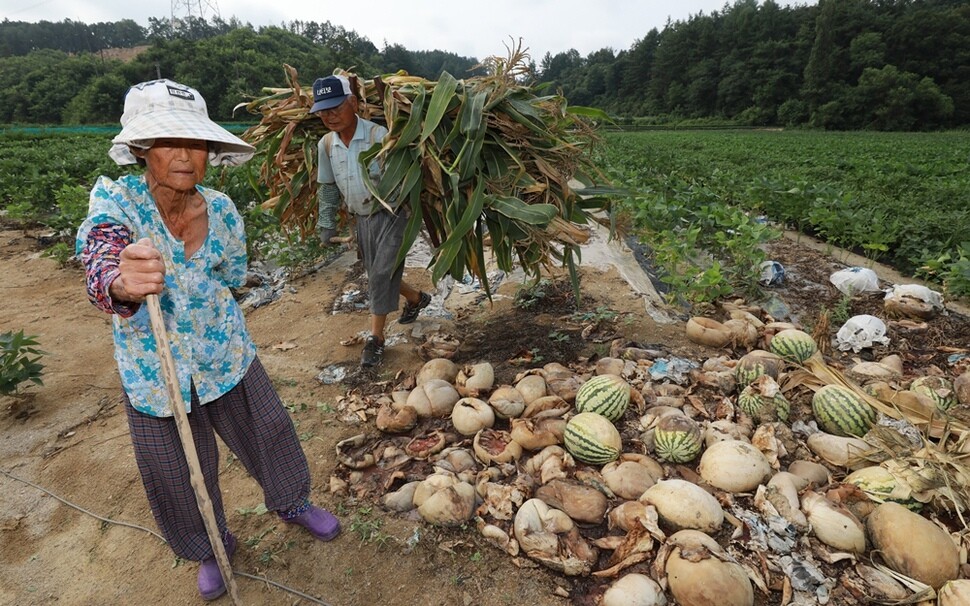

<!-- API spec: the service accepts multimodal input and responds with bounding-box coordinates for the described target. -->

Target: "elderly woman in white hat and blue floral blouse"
[76,80,340,600]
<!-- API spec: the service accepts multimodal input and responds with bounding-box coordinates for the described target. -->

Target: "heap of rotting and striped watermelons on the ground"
[331,310,970,606]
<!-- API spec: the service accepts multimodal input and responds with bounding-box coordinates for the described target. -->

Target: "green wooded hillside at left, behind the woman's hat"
[0,18,477,124]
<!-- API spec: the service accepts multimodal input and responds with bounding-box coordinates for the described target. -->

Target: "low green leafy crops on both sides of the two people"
[0,130,970,301]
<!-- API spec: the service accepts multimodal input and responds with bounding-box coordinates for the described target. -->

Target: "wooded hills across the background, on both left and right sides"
[0,0,970,130]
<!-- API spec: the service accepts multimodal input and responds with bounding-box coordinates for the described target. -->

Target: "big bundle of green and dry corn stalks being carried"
[235,44,620,295]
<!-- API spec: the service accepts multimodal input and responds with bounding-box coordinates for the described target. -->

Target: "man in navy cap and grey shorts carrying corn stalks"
[310,76,431,367]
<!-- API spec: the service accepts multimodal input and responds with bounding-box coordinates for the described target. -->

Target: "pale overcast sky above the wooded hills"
[0,0,815,63]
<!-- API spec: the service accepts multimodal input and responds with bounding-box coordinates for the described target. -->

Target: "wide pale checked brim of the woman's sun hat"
[109,110,256,166]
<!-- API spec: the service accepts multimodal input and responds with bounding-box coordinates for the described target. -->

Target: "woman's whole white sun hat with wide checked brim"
[108,79,256,166]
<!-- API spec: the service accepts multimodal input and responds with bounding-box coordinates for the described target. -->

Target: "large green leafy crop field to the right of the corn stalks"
[601,130,970,300]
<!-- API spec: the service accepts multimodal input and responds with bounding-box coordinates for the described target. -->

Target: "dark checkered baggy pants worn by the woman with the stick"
[124,358,310,560]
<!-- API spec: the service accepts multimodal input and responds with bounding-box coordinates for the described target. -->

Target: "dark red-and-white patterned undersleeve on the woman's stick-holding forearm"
[81,223,140,318]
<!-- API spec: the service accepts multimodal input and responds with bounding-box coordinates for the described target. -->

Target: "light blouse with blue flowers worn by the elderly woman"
[75,175,256,417]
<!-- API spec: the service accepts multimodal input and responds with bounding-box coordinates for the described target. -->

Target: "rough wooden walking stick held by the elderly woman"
[145,295,242,605]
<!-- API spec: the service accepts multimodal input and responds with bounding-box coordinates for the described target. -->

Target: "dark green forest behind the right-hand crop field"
[539,0,970,130]
